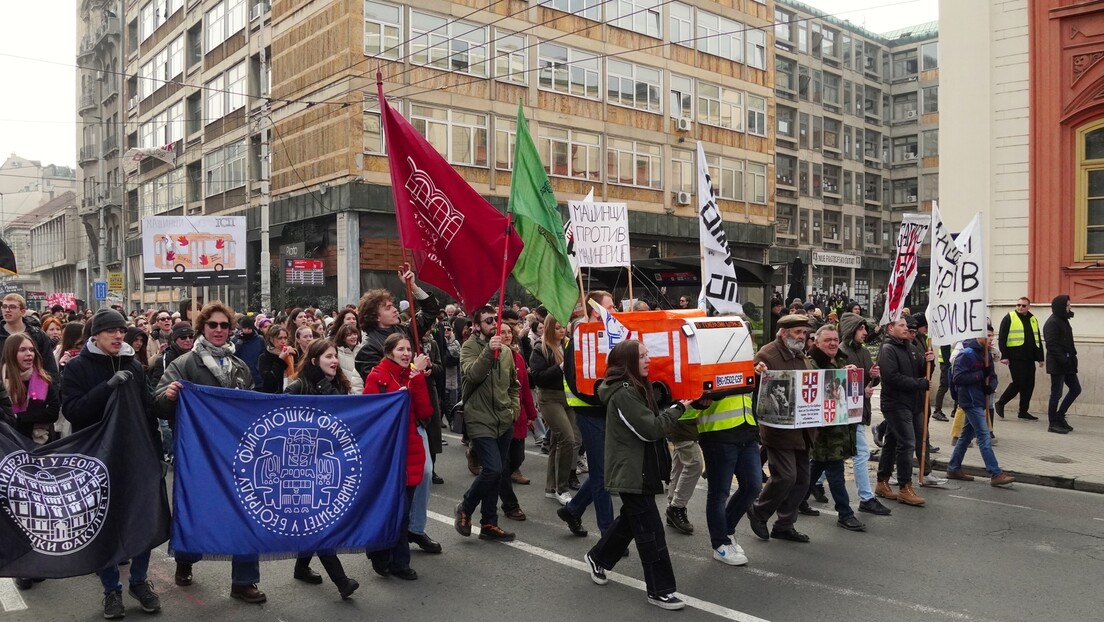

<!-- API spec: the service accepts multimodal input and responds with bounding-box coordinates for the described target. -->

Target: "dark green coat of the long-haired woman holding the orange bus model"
[598,380,684,495]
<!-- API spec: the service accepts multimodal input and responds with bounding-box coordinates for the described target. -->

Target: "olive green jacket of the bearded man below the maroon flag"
[460,335,521,439]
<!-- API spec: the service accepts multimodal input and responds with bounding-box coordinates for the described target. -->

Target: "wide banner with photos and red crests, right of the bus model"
[755,369,866,429]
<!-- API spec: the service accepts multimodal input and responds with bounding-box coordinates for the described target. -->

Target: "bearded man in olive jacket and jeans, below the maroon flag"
[454,305,521,541]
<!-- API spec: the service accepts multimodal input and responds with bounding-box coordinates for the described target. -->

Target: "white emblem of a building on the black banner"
[0,451,110,555]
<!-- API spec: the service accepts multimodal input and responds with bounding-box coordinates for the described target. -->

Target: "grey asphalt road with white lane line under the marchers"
[0,436,1104,622]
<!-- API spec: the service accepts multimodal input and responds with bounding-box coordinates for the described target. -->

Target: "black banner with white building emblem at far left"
[0,382,169,579]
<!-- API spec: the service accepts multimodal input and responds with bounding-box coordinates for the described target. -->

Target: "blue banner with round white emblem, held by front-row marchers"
[171,382,410,558]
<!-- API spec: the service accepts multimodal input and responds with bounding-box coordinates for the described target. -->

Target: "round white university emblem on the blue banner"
[234,407,363,536]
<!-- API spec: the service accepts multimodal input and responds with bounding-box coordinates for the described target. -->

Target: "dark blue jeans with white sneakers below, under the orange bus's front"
[699,440,763,549]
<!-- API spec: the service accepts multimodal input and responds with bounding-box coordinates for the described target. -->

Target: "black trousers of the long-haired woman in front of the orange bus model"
[590,493,675,597]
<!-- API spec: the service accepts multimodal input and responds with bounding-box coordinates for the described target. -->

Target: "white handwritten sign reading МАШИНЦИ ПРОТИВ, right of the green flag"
[567,201,631,267]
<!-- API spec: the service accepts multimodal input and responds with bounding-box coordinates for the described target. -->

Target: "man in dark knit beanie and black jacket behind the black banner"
[61,309,161,620]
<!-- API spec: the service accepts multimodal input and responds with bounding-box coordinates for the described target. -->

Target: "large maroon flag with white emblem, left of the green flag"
[380,84,522,314]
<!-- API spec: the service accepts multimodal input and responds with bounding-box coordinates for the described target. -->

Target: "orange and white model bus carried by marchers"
[573,309,755,403]
